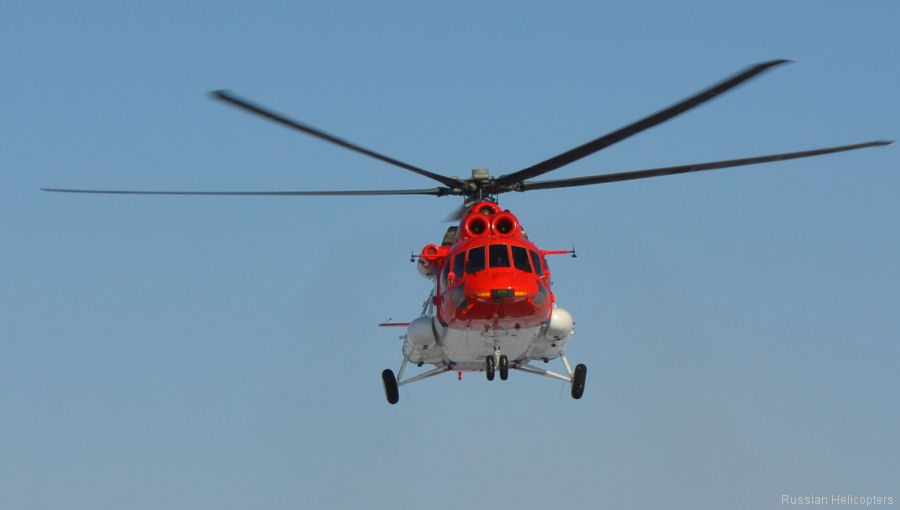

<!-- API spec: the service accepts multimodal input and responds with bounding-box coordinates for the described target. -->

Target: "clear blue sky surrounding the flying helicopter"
[0,0,900,510]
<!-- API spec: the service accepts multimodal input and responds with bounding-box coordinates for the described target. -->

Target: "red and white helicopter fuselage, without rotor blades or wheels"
[403,202,574,371]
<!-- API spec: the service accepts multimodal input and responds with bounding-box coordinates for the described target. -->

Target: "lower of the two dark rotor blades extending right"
[517,140,894,191]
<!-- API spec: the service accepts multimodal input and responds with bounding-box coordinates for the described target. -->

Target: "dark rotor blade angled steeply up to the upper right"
[496,60,790,188]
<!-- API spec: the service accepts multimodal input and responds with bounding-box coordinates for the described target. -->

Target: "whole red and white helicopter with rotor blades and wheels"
[41,59,893,405]
